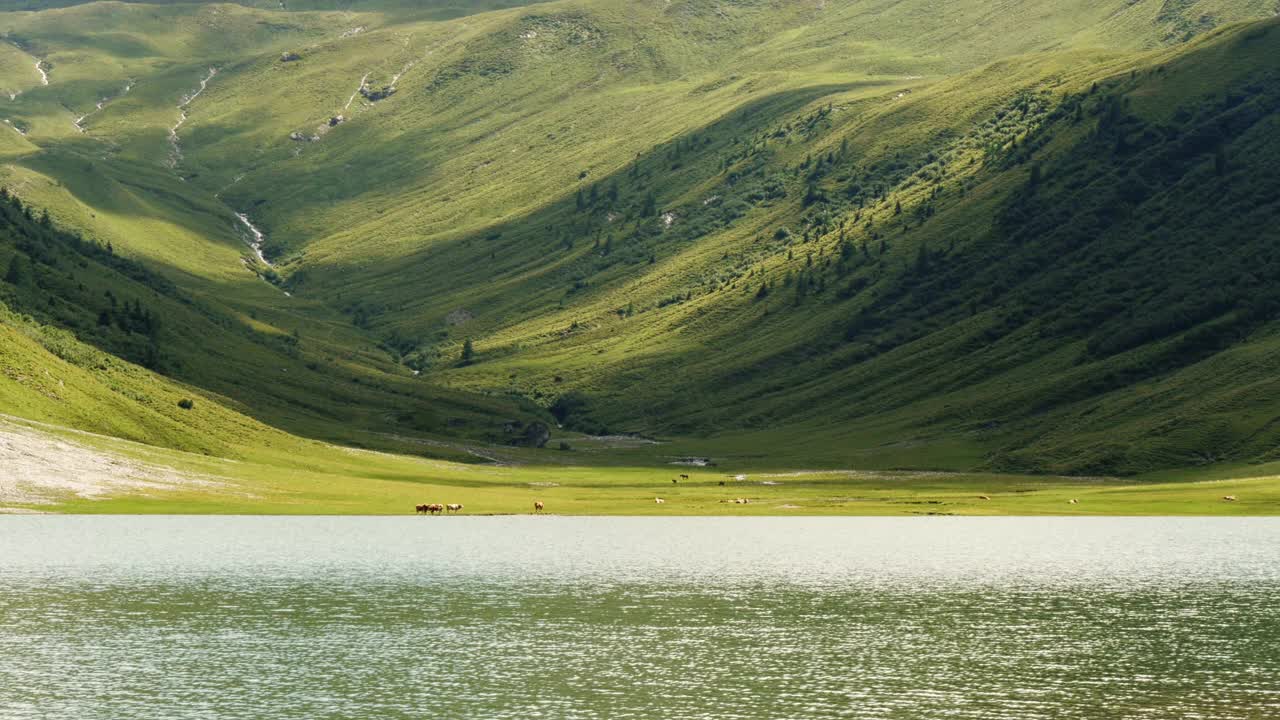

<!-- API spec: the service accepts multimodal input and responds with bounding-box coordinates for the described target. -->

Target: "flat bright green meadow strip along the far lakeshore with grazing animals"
[10,409,1280,516]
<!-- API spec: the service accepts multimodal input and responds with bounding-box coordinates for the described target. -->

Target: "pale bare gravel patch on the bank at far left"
[0,419,221,511]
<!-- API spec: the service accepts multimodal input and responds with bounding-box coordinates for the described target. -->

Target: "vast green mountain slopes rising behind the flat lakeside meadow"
[0,0,1280,507]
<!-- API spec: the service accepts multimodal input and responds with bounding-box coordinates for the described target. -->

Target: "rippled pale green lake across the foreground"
[0,516,1280,720]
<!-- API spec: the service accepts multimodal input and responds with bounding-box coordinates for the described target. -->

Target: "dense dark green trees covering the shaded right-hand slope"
[819,61,1280,401]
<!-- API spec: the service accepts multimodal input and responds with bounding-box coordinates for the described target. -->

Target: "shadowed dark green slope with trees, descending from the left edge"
[0,185,545,455]
